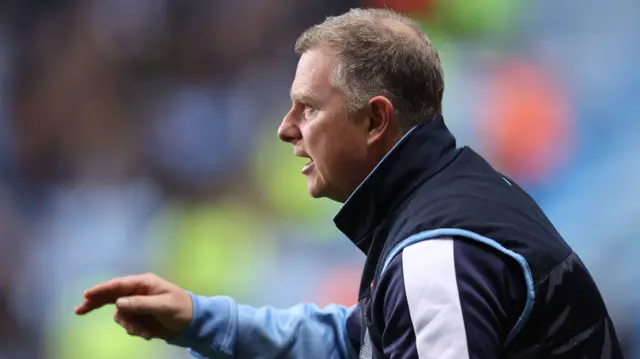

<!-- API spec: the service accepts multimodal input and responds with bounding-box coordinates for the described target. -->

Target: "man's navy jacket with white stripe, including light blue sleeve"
[170,117,622,359]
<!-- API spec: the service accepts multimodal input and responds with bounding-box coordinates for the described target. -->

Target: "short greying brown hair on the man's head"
[295,9,444,131]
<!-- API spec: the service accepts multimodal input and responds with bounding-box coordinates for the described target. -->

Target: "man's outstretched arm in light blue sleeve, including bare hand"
[76,274,360,359]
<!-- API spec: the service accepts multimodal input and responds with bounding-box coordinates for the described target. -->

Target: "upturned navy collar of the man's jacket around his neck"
[333,116,456,253]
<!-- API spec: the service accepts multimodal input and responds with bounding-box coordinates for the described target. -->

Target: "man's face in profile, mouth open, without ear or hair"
[278,48,375,202]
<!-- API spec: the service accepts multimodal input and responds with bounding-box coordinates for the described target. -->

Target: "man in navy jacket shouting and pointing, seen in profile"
[76,10,622,359]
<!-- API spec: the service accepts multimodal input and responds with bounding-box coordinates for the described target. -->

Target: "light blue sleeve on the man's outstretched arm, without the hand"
[168,295,357,359]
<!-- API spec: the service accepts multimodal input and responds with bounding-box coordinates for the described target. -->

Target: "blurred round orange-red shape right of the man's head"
[478,60,573,186]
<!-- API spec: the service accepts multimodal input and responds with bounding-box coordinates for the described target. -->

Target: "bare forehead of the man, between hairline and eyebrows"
[291,49,335,100]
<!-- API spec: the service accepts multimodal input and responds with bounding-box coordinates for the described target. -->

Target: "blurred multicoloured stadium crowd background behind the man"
[0,0,640,359]
